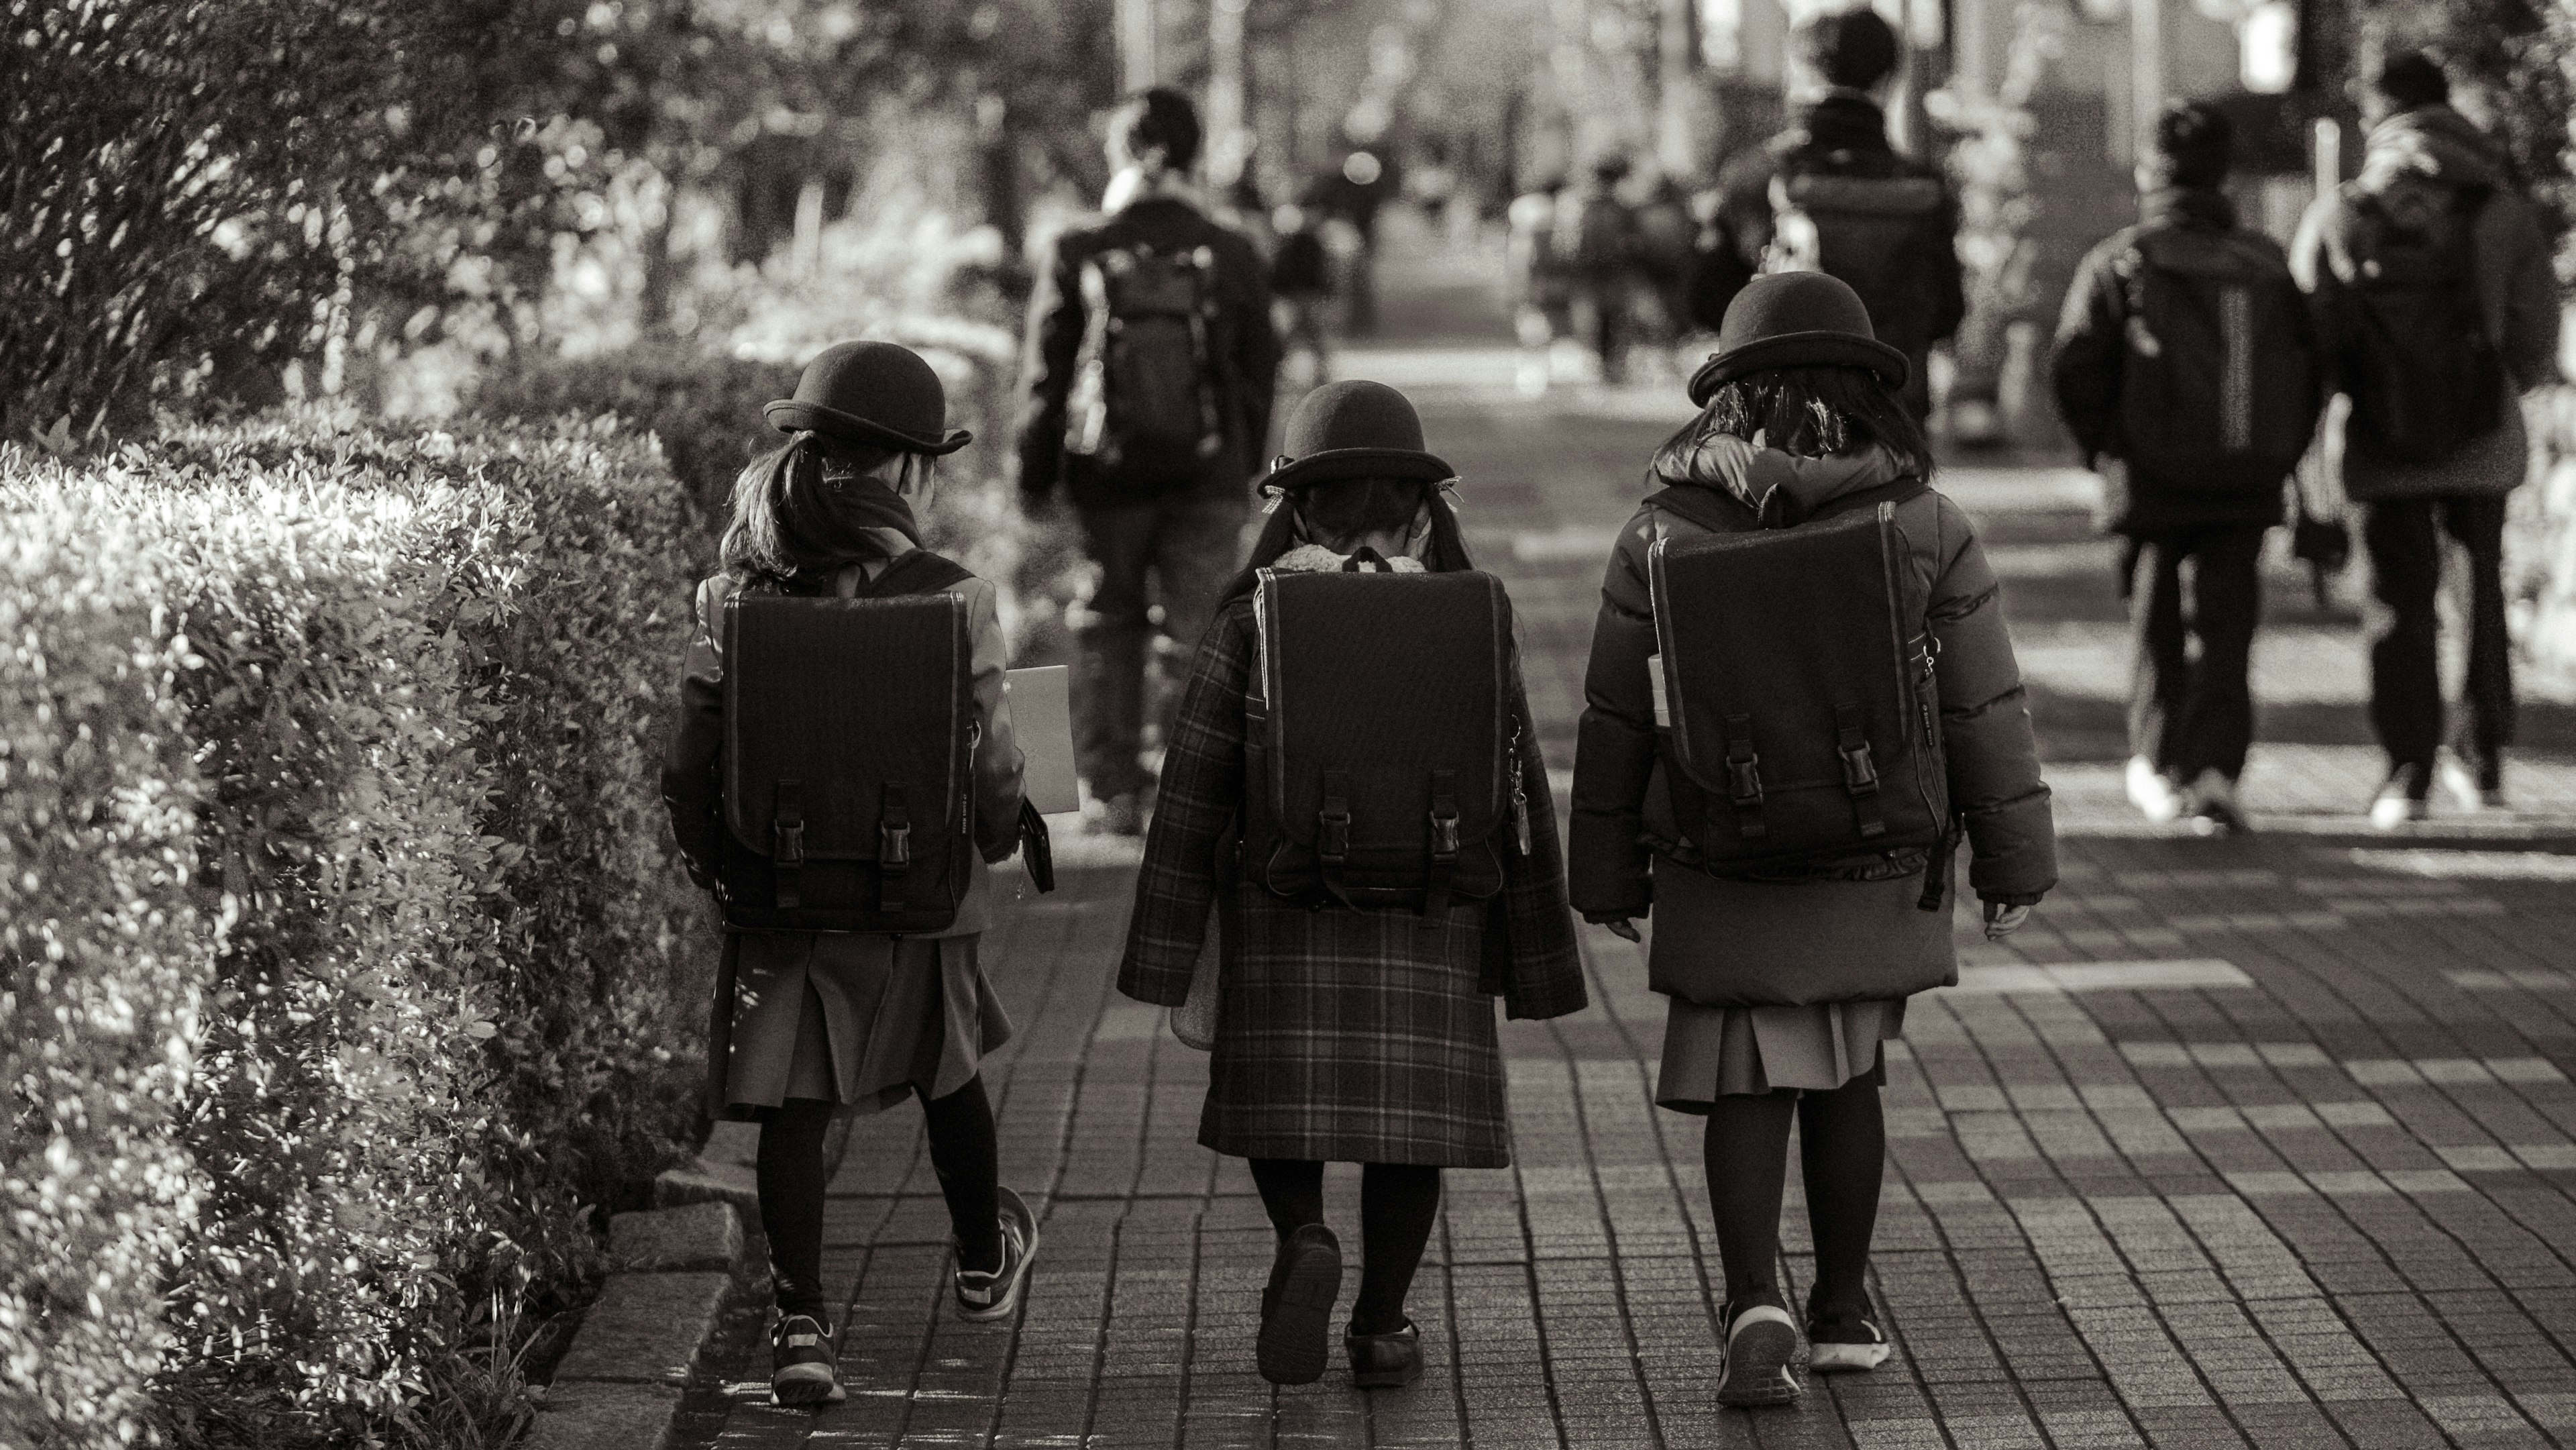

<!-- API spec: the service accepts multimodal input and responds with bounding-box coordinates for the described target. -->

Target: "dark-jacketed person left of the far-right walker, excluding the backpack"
[2053,101,2321,829]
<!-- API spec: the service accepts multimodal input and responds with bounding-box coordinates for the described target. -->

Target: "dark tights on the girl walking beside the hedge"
[757,1076,1002,1318]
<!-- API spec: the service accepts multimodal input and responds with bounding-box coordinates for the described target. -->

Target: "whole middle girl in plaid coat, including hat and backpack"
[1118,381,1585,1388]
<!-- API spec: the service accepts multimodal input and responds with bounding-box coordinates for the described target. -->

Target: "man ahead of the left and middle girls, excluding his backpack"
[1020,88,1280,835]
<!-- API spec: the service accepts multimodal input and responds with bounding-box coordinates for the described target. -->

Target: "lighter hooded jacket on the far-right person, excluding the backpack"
[2290,105,2558,502]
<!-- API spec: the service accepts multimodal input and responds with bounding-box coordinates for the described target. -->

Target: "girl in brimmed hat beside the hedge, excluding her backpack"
[662,343,1038,1404]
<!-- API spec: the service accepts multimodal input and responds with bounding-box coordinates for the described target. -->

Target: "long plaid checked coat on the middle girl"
[1118,579,1585,1170]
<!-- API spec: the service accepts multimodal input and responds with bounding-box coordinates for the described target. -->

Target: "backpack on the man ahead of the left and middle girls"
[1064,242,1226,489]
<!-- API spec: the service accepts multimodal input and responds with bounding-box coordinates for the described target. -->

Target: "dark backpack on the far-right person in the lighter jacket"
[2342,183,2504,466]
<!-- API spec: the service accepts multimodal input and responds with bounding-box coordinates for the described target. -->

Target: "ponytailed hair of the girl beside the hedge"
[716,433,932,584]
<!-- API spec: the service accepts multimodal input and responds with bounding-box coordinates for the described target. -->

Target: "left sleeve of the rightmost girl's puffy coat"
[1571,510,1654,917]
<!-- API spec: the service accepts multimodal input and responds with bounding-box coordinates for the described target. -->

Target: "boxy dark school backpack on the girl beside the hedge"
[716,549,979,932]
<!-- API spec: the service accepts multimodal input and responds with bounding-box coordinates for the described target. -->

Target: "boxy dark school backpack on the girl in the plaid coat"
[1242,554,1530,917]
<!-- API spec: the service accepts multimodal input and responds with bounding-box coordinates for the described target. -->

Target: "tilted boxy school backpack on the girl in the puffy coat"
[1646,479,1953,909]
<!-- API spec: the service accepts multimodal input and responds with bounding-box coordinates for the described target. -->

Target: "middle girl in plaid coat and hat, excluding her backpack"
[1118,381,1585,1386]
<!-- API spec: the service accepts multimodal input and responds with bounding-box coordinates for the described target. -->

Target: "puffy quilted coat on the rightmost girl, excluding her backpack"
[1571,435,2058,1007]
